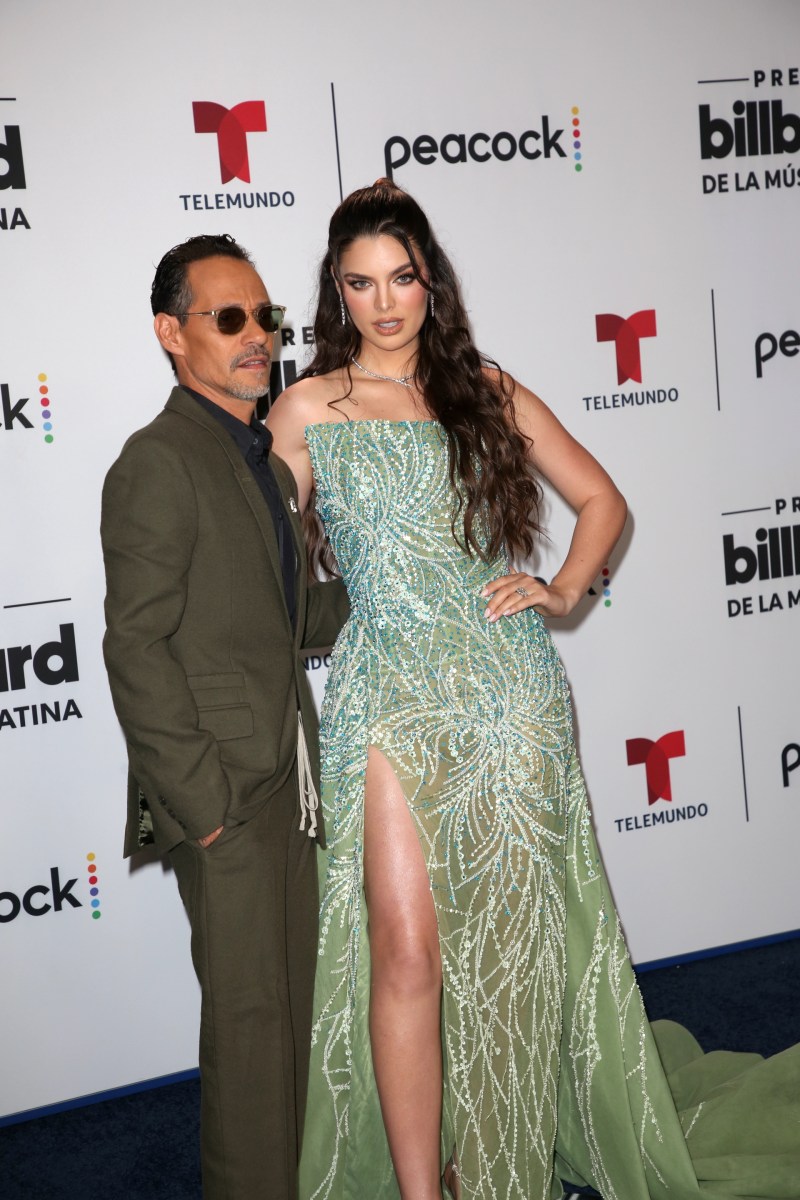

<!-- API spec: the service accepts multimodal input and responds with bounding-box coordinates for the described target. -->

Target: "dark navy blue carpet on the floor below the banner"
[0,938,800,1200]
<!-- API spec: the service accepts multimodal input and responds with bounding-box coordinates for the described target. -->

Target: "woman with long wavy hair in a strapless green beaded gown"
[269,180,800,1200]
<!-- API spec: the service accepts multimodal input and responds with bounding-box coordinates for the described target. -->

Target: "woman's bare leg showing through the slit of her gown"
[363,746,441,1200]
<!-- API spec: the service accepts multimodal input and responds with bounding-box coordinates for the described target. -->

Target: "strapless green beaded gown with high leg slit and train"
[300,420,800,1200]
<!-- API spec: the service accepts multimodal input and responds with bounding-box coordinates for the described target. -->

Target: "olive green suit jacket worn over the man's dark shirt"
[101,388,348,854]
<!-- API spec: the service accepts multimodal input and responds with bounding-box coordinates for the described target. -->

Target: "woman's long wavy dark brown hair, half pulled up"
[300,179,541,574]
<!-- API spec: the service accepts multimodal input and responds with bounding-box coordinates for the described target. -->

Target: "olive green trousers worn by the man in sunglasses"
[170,774,318,1200]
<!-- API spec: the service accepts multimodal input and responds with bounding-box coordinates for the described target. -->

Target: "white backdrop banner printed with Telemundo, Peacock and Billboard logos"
[0,0,800,1116]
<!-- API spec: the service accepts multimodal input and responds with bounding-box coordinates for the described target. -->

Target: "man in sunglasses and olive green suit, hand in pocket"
[102,235,348,1200]
